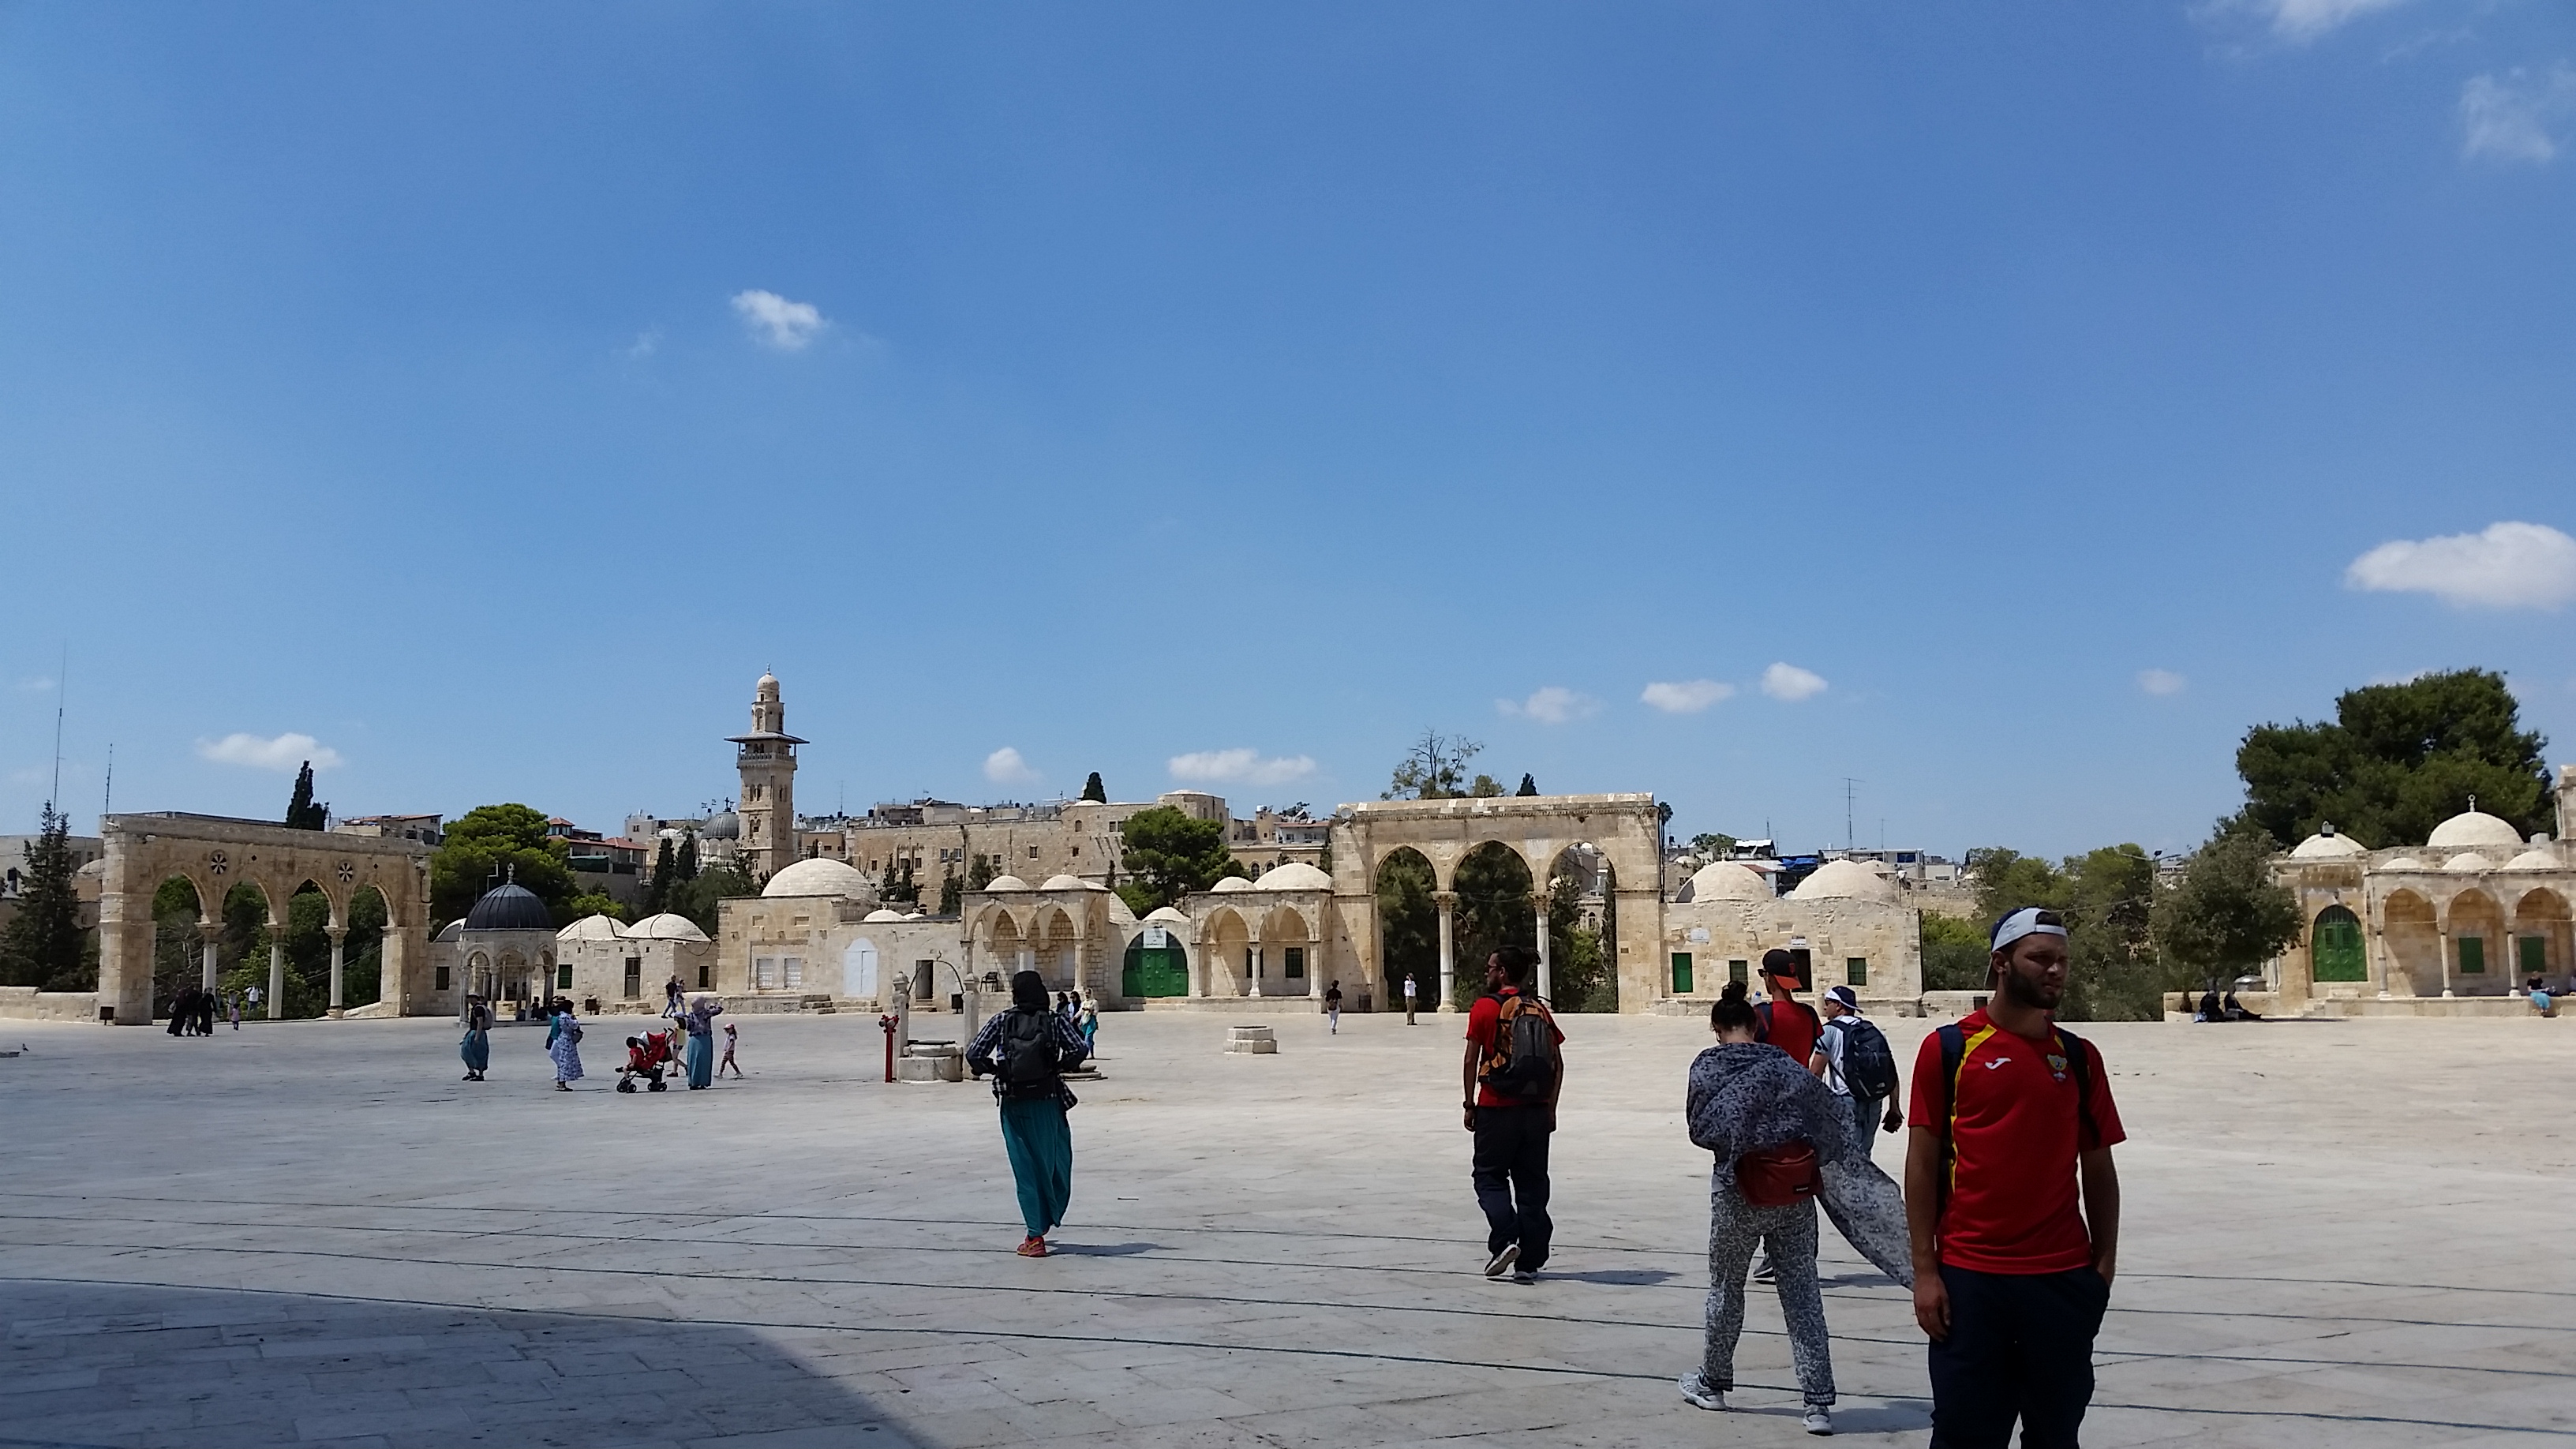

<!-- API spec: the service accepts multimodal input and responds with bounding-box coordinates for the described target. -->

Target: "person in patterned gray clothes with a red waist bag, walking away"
[1682,983,1914,1433]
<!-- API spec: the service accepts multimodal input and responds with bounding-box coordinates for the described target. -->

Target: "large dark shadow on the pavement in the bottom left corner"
[0,1279,912,1449]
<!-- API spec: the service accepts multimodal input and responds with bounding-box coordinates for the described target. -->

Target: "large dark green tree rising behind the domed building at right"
[2236,670,2550,848]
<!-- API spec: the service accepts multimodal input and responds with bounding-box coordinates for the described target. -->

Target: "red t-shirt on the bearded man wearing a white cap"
[1914,1011,2128,1274]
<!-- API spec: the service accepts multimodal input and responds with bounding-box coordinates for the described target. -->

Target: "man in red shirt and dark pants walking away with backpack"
[1466,946,1567,1284]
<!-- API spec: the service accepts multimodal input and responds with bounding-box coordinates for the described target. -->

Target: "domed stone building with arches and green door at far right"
[2275,766,2576,1016]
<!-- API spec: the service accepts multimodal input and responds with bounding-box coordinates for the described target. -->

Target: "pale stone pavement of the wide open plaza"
[0,1013,2576,1449]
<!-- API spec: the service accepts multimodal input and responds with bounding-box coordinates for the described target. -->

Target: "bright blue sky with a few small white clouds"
[0,0,2576,853]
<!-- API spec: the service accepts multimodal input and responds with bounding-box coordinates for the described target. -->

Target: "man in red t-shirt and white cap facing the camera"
[1906,908,2125,1449]
